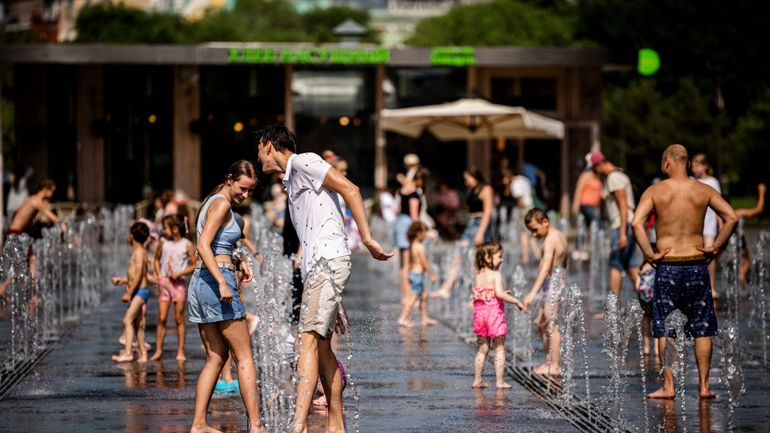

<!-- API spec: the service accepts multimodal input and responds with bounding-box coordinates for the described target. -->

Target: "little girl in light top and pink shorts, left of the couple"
[151,214,195,361]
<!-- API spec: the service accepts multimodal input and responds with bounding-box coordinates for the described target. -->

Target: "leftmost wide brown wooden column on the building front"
[75,65,106,203]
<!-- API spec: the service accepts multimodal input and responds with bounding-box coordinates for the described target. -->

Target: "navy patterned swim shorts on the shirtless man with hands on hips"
[652,256,719,338]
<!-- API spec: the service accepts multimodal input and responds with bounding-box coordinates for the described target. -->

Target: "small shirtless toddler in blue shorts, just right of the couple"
[398,221,437,326]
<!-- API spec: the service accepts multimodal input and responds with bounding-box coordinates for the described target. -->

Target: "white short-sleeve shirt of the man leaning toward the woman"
[283,152,350,280]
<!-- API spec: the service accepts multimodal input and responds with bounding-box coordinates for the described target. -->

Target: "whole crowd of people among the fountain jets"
[0,134,766,432]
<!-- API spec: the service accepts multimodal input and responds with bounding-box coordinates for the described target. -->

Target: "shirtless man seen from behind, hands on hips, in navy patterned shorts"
[631,144,738,399]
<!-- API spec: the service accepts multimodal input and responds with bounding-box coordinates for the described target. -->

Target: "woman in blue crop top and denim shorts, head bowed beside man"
[188,160,265,433]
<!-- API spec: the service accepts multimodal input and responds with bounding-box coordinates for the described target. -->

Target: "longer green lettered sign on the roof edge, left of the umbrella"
[227,48,390,65]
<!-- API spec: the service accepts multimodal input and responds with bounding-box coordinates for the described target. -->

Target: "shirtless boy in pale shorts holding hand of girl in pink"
[524,208,567,376]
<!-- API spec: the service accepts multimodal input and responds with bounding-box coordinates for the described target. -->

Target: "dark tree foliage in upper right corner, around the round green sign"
[576,0,770,186]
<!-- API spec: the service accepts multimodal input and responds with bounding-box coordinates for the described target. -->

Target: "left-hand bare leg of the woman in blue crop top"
[190,323,228,433]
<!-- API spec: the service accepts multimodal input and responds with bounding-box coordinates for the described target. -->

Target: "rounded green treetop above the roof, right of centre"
[407,0,575,46]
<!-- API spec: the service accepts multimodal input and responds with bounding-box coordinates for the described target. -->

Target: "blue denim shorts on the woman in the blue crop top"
[187,267,246,323]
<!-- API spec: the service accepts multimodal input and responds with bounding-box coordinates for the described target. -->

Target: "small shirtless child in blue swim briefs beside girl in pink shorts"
[112,222,150,362]
